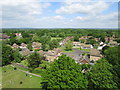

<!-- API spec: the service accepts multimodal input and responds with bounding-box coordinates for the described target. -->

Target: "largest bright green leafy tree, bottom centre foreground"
[42,55,88,89]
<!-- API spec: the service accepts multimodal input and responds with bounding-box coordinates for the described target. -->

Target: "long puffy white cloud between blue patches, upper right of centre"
[55,0,109,15]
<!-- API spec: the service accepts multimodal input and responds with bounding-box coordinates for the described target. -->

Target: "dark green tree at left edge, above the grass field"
[2,44,14,66]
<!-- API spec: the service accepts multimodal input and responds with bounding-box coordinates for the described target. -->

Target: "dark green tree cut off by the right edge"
[104,46,120,88]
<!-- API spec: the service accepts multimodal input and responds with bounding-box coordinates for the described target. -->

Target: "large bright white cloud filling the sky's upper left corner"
[0,0,51,20]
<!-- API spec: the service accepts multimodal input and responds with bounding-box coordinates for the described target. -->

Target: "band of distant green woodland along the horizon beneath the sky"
[3,29,119,37]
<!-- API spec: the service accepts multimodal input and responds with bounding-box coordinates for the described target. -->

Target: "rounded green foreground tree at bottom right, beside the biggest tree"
[88,59,117,89]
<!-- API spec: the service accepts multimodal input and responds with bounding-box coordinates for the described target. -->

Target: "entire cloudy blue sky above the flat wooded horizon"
[0,0,118,28]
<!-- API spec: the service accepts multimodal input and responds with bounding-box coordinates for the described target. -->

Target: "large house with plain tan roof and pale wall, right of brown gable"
[90,49,102,61]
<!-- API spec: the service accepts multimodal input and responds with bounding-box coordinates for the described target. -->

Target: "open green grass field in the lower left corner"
[2,65,41,88]
